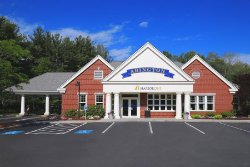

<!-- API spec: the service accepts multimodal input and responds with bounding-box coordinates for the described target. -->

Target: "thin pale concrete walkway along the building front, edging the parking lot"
[51,118,250,123]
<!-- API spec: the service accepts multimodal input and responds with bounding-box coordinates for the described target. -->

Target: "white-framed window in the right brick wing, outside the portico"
[190,95,214,111]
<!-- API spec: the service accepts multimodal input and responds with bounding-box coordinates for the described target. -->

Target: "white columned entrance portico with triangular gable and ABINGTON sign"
[102,43,194,119]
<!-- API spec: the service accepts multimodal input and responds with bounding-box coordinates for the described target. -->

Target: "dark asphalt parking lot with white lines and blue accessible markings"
[0,122,250,167]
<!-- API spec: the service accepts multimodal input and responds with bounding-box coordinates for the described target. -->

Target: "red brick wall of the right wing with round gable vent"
[184,60,233,113]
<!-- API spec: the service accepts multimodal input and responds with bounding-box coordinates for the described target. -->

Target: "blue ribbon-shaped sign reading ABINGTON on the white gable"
[122,67,174,78]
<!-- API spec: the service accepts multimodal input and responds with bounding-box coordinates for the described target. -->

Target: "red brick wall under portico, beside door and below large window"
[140,93,175,118]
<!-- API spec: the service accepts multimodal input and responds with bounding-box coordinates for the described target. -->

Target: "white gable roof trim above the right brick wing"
[181,55,238,93]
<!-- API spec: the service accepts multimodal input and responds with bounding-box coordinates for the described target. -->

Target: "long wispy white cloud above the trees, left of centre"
[51,25,127,46]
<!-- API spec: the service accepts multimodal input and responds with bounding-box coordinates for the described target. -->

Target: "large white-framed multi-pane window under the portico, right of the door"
[148,94,176,111]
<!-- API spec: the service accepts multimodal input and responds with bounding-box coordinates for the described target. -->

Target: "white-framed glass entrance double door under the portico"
[122,98,138,117]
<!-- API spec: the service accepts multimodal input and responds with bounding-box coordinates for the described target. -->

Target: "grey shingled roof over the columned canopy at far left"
[6,72,74,94]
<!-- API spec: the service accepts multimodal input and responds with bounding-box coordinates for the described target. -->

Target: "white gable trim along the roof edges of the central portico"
[103,42,194,83]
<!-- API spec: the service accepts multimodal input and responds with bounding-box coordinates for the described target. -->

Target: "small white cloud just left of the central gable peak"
[109,46,132,60]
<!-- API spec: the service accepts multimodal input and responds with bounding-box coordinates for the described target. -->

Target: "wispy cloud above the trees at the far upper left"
[5,16,43,35]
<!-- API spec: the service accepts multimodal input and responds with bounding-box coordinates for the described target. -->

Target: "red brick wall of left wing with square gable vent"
[62,60,111,114]
